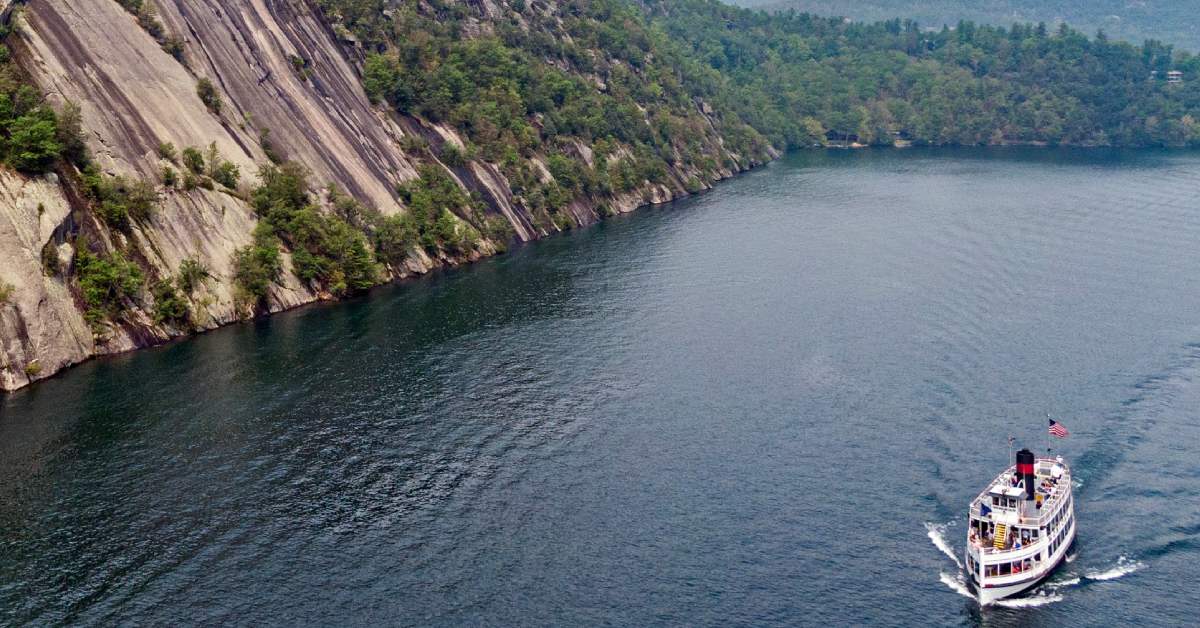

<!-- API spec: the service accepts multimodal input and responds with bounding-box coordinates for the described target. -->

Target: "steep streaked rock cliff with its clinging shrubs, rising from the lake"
[0,0,775,390]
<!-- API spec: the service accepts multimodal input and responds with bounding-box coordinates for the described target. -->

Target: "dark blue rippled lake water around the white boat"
[0,149,1200,626]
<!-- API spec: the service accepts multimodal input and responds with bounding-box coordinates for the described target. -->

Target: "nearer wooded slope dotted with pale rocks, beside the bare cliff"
[320,0,770,218]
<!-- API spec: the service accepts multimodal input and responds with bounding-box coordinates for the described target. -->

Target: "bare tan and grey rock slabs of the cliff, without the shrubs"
[0,0,768,390]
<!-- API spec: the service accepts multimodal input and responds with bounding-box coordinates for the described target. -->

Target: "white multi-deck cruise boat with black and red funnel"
[966,449,1075,605]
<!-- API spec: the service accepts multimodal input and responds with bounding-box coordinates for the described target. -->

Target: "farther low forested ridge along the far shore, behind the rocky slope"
[649,0,1200,145]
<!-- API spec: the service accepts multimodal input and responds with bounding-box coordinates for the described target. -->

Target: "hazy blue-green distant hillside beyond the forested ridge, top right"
[733,0,1200,50]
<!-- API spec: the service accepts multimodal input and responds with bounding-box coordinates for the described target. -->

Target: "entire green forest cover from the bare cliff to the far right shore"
[322,0,1200,184]
